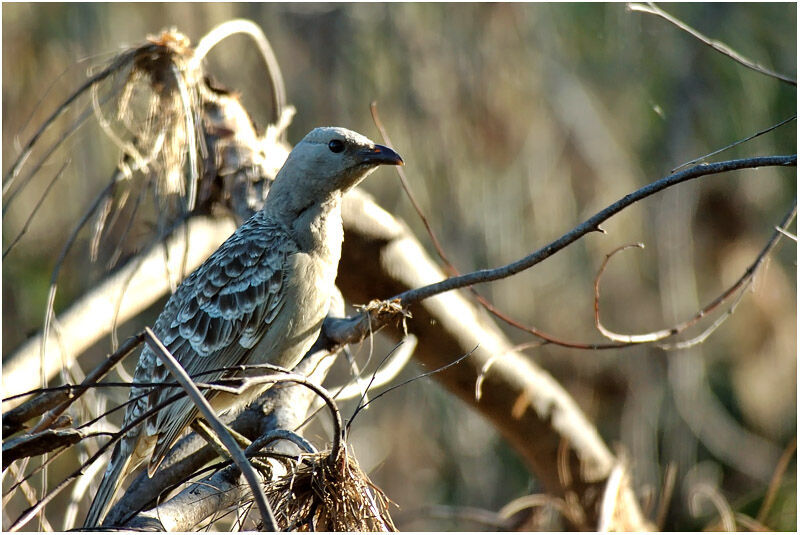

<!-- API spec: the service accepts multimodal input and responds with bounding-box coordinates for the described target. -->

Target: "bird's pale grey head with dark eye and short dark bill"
[270,127,403,214]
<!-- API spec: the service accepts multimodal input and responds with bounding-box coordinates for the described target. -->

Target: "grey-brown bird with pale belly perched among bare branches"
[84,127,403,527]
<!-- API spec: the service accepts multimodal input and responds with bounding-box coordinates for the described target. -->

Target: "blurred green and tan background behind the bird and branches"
[2,3,797,531]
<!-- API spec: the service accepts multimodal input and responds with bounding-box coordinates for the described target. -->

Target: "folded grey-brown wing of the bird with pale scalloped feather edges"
[128,212,298,473]
